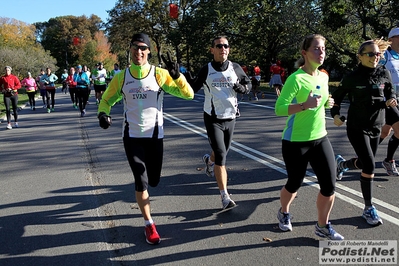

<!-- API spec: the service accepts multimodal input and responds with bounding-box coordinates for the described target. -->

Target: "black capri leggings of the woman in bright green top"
[282,137,336,197]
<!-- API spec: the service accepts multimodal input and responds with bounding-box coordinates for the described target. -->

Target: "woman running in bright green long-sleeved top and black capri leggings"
[275,34,344,240]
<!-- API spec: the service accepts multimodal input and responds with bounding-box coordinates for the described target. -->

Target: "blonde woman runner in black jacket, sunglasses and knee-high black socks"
[331,40,397,225]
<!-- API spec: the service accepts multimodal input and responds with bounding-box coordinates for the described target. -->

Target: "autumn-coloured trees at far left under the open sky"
[0,15,117,78]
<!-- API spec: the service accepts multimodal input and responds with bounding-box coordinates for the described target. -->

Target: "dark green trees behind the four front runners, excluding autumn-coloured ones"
[105,0,399,80]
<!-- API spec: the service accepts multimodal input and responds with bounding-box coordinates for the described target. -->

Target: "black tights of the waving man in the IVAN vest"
[123,137,163,192]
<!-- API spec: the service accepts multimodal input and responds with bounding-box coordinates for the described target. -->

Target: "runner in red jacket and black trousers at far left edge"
[0,66,21,129]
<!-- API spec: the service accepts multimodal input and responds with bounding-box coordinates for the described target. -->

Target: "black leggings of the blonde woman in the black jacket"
[346,128,380,175]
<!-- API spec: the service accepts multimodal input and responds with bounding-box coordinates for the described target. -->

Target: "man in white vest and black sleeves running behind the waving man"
[184,36,251,210]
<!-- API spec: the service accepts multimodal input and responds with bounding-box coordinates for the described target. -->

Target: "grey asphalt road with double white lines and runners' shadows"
[0,90,399,266]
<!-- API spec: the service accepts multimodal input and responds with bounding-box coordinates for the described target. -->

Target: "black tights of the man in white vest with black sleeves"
[204,112,236,166]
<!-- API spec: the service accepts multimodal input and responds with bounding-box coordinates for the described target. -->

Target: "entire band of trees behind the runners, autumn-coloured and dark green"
[0,0,399,79]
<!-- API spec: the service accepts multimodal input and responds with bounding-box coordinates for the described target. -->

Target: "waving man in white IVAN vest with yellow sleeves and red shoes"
[98,33,194,244]
